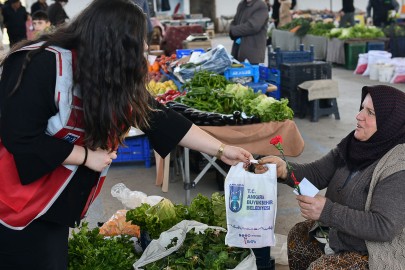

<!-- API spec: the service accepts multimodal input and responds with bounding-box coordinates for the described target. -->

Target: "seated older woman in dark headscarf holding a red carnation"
[256,85,405,269]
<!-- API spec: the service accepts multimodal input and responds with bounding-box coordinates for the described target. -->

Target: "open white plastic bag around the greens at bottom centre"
[134,220,257,270]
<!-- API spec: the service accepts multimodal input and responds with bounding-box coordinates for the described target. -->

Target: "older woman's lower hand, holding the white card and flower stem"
[296,195,326,220]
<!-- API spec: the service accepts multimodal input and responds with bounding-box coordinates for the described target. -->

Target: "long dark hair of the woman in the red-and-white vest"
[0,0,153,150]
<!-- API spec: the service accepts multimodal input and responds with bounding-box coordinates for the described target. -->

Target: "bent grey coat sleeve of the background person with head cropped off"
[231,3,269,37]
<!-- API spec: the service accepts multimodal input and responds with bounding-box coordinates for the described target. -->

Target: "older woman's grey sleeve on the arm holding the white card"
[319,171,405,242]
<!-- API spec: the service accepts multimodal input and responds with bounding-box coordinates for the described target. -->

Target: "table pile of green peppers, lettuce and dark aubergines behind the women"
[171,71,293,123]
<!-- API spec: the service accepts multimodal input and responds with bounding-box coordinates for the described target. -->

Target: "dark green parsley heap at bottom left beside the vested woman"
[68,222,139,270]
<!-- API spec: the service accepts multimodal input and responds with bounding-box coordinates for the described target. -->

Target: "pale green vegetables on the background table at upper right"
[327,25,385,39]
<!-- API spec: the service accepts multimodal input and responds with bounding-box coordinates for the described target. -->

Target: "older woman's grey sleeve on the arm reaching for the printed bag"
[278,148,339,190]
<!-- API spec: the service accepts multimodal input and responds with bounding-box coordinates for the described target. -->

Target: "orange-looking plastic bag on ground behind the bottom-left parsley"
[100,210,140,238]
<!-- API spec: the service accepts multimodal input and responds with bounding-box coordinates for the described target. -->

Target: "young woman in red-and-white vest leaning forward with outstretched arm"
[0,0,252,270]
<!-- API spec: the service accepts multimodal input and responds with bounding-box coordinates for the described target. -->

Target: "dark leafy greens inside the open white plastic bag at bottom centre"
[143,229,251,270]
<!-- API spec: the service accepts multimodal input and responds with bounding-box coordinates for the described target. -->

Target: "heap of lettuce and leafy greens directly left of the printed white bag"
[126,192,226,239]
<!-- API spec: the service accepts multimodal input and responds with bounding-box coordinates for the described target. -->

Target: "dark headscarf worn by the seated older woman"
[338,85,405,172]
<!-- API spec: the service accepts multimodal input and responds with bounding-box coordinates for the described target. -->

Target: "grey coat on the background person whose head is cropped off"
[230,0,269,64]
